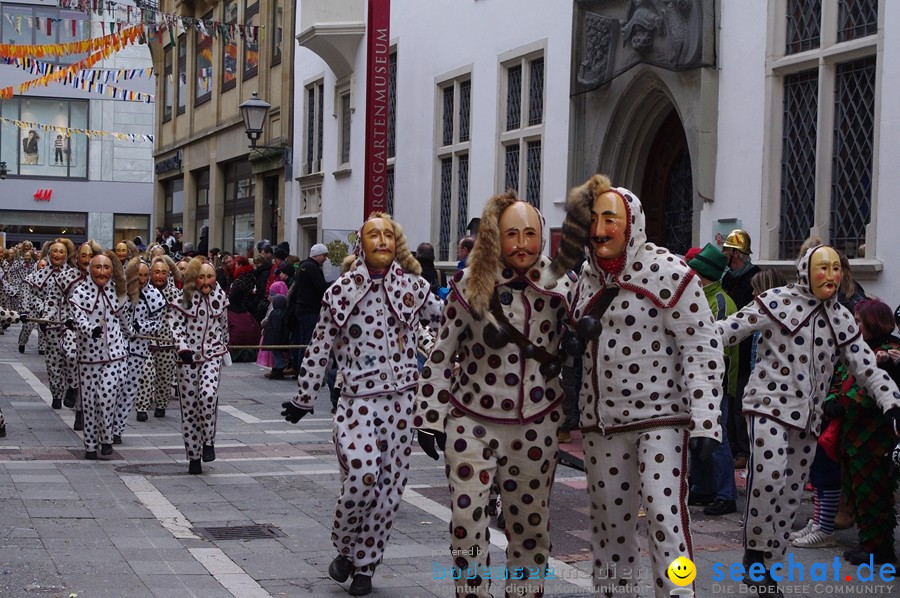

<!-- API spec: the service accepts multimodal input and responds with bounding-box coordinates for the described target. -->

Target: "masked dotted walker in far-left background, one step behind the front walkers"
[34,238,80,409]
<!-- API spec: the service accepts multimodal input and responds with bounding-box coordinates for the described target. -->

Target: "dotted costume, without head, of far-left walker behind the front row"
[35,264,81,408]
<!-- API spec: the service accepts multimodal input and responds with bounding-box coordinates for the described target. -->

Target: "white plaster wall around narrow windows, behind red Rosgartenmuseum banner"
[288,0,572,252]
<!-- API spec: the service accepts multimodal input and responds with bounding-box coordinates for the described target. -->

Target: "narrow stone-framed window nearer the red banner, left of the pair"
[432,71,472,261]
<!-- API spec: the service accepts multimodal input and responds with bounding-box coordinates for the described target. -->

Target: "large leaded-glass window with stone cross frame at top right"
[768,0,880,260]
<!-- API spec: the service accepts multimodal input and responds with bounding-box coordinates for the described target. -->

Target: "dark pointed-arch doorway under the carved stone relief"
[641,108,694,255]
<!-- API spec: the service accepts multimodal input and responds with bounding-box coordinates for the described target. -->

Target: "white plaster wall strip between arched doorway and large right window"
[700,0,764,258]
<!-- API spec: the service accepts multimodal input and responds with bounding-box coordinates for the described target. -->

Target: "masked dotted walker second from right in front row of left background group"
[113,257,167,444]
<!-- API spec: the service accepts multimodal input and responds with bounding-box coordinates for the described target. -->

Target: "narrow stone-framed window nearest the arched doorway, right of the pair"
[498,51,545,209]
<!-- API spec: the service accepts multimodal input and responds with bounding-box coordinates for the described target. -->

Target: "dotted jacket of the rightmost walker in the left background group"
[166,285,228,363]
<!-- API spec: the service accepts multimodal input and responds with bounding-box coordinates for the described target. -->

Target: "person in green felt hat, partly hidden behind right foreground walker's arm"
[685,243,738,516]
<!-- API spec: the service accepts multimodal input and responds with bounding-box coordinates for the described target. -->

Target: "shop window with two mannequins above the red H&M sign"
[0,97,88,178]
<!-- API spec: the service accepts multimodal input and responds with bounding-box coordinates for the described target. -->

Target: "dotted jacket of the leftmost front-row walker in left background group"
[69,278,128,364]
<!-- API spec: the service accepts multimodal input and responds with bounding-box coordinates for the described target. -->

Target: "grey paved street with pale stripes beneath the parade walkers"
[0,326,900,598]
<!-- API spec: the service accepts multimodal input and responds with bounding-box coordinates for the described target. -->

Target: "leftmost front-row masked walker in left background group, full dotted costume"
[68,251,128,459]
